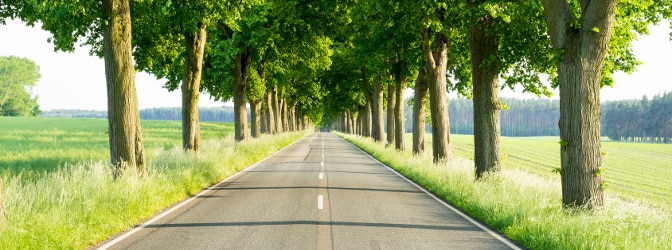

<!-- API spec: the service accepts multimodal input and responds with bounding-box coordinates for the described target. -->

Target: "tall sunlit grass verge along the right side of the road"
[341,135,672,249]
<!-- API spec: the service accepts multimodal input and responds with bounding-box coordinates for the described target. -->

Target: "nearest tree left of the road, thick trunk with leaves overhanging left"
[19,0,146,177]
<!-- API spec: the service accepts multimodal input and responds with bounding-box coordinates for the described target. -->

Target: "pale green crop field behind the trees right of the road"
[451,135,672,206]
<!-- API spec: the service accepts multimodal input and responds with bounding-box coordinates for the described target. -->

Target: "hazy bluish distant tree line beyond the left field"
[40,106,238,122]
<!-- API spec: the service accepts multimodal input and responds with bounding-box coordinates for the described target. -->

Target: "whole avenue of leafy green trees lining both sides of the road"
[0,0,672,209]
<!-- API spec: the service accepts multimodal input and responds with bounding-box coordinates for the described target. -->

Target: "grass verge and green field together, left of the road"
[0,117,308,249]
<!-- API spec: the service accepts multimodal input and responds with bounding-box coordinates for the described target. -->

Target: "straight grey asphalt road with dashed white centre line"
[100,133,517,249]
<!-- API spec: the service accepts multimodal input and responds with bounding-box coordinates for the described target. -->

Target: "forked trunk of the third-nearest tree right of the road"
[420,28,451,162]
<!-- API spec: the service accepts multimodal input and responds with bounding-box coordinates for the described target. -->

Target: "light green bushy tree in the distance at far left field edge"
[0,56,40,116]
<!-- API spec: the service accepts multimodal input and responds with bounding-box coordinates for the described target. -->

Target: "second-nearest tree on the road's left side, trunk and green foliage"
[132,0,257,151]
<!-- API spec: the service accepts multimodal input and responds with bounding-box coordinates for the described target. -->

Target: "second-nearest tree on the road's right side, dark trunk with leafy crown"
[468,1,552,178]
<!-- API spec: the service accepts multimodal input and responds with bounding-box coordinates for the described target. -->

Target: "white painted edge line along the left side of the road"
[97,137,306,250]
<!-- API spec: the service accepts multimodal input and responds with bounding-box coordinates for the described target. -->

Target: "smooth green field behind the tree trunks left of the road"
[0,117,233,178]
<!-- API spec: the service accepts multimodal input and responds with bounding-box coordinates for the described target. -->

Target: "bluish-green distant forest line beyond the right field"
[406,92,672,143]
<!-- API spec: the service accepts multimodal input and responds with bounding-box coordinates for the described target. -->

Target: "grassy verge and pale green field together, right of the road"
[341,135,672,249]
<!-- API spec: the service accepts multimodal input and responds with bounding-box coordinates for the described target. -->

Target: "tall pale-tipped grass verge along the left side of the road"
[0,120,306,249]
